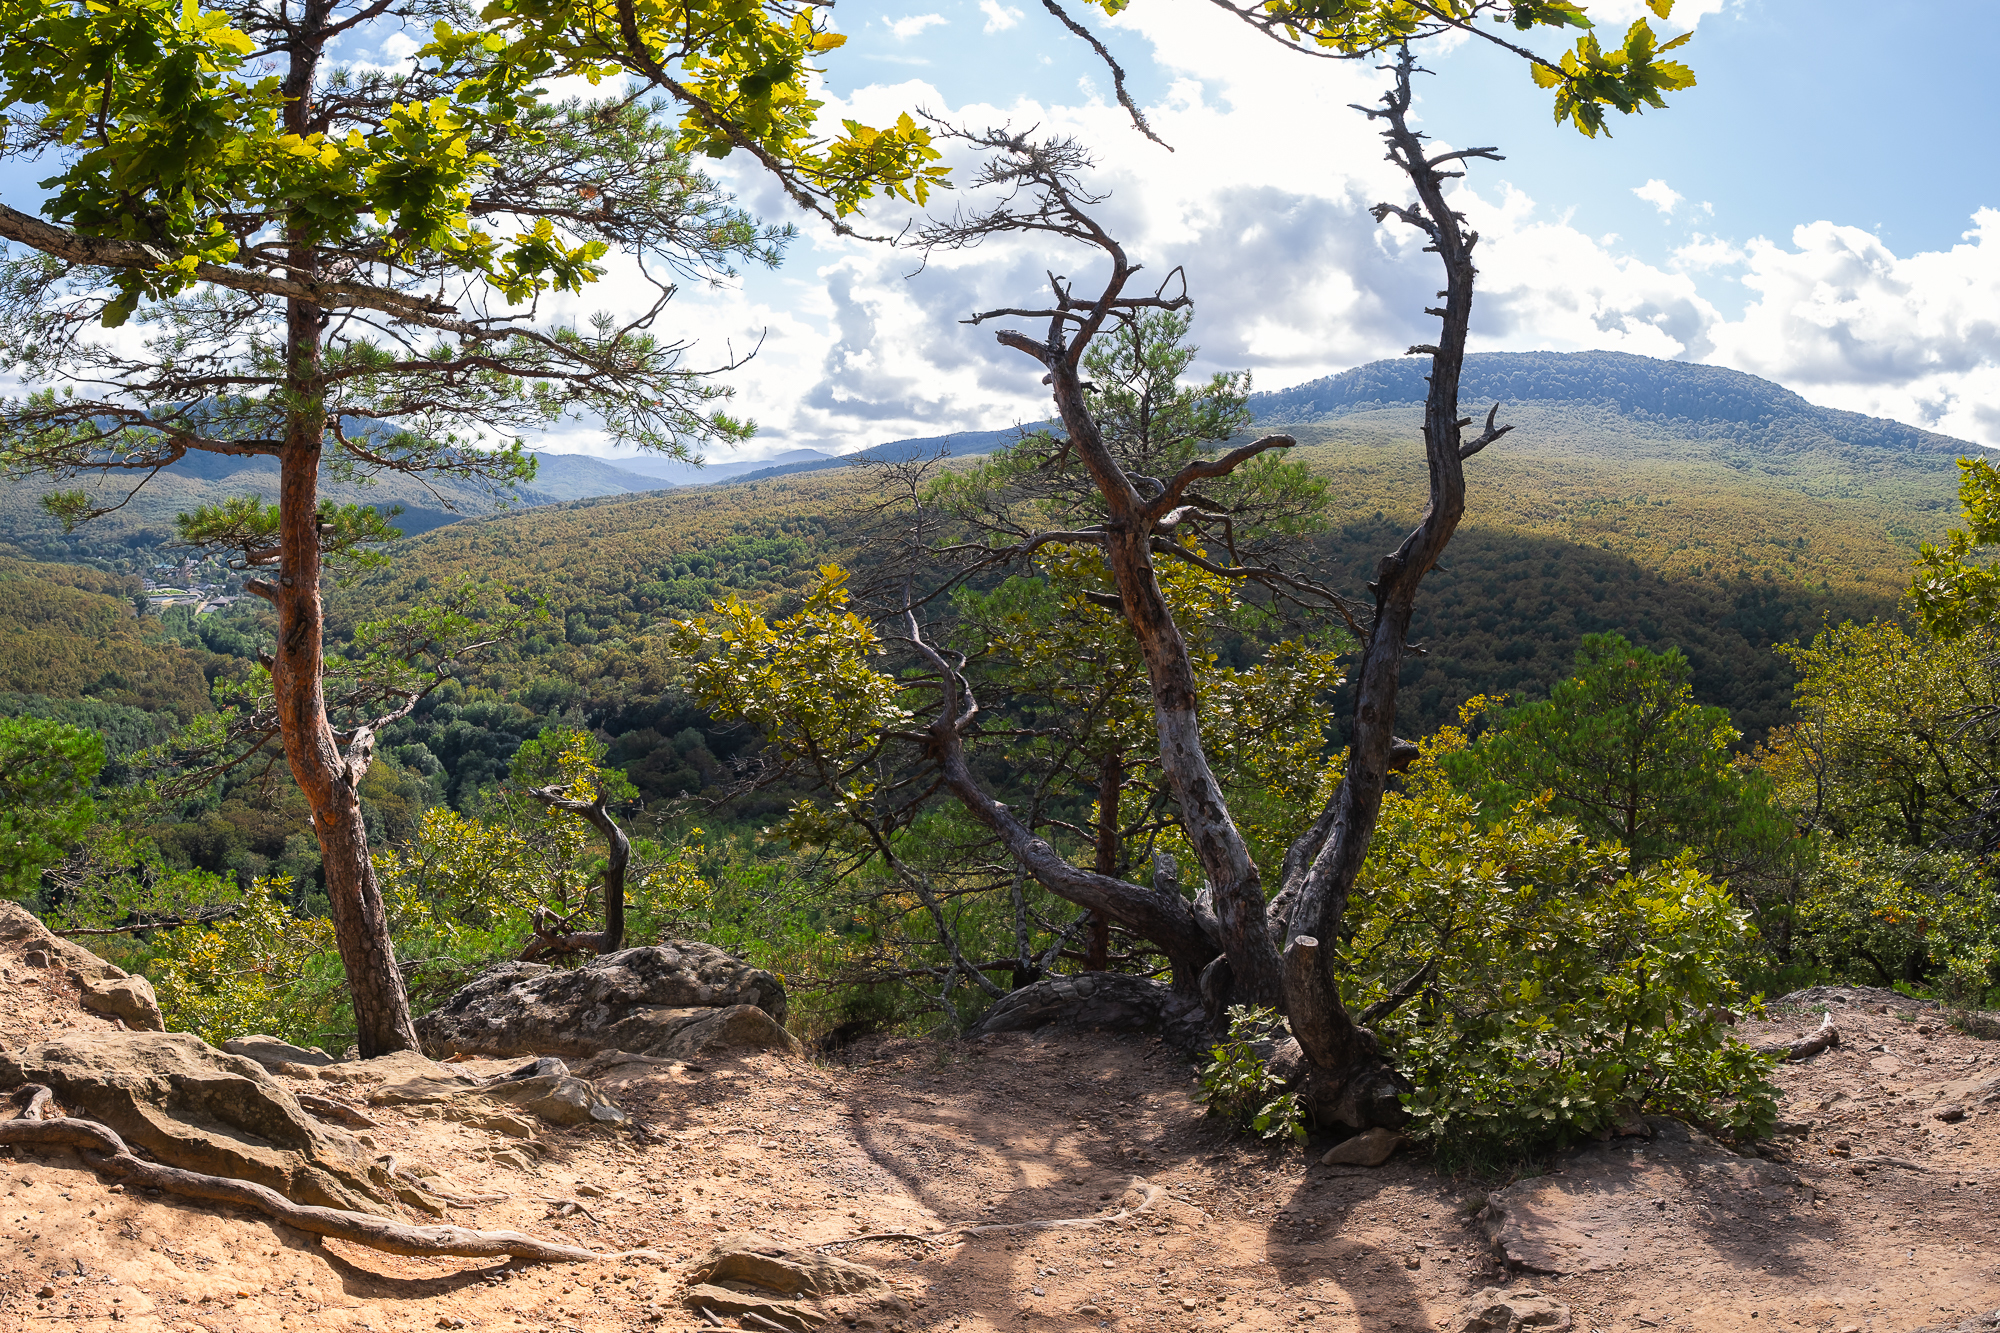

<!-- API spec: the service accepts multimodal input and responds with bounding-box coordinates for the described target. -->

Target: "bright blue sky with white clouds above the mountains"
[11,0,2000,456]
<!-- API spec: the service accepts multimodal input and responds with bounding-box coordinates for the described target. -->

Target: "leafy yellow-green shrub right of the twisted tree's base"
[1346,729,1776,1157]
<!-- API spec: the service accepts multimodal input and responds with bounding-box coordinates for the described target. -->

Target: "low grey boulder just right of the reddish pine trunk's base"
[416,941,800,1059]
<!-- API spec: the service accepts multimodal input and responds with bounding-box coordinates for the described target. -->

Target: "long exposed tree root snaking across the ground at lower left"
[0,1085,662,1263]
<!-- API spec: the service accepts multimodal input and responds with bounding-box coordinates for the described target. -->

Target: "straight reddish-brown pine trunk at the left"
[254,0,418,1059]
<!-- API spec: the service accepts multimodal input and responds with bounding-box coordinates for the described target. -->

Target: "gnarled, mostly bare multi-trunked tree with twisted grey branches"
[902,52,1508,1127]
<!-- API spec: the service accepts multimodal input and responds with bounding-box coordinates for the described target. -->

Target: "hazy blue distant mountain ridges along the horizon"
[0,352,1976,558]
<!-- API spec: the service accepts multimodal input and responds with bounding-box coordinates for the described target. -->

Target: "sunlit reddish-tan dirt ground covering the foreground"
[0,924,2000,1333]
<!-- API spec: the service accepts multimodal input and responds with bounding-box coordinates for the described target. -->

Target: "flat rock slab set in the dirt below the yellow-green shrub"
[1486,1117,1812,1273]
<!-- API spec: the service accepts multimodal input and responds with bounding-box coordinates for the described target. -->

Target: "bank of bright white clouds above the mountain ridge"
[512,0,2000,454]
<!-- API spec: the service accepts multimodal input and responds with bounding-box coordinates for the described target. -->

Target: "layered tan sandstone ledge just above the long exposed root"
[0,1033,388,1213]
